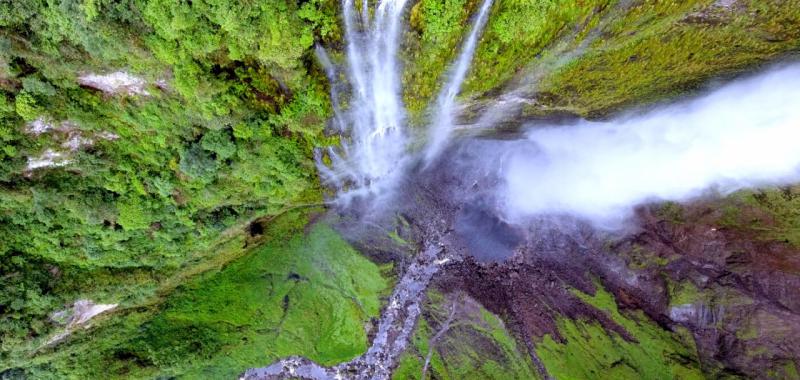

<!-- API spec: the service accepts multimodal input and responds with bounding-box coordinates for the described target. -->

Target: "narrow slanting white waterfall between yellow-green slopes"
[425,0,492,164]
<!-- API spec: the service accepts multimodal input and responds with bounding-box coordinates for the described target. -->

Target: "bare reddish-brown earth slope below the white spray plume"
[436,197,800,378]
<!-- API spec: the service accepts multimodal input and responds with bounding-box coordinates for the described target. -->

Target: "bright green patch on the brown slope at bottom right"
[536,286,704,379]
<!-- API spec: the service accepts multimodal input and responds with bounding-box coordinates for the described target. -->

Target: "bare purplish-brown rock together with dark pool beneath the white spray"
[403,141,800,378]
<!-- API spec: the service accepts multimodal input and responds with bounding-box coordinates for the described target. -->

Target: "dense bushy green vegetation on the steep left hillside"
[0,0,339,368]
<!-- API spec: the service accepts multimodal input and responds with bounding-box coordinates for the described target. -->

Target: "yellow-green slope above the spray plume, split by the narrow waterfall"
[404,0,800,124]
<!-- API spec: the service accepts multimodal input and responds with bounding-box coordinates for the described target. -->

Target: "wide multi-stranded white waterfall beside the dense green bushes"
[317,0,408,203]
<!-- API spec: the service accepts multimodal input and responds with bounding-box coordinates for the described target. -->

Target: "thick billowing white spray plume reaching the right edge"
[500,65,800,227]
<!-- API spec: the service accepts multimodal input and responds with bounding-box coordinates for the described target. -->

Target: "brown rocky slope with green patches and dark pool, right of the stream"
[382,142,800,378]
